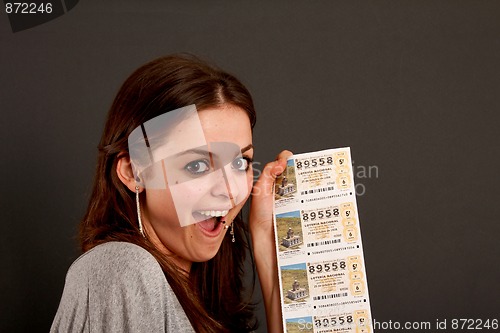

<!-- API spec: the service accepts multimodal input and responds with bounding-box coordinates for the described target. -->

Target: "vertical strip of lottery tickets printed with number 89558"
[274,148,372,333]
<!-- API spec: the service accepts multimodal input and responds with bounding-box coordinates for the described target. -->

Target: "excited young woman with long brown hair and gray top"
[51,55,291,333]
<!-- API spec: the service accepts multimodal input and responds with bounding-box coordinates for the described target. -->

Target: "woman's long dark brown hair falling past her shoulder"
[80,54,256,332]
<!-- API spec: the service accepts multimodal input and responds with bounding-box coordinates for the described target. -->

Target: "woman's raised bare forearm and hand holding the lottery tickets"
[249,150,292,332]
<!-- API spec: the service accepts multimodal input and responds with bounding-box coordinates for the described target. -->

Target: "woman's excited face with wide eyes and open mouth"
[142,104,253,270]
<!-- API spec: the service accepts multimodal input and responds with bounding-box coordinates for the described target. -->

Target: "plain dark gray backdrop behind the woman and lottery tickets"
[0,0,500,332]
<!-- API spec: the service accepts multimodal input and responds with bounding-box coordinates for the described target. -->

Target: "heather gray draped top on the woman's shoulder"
[50,242,194,333]
